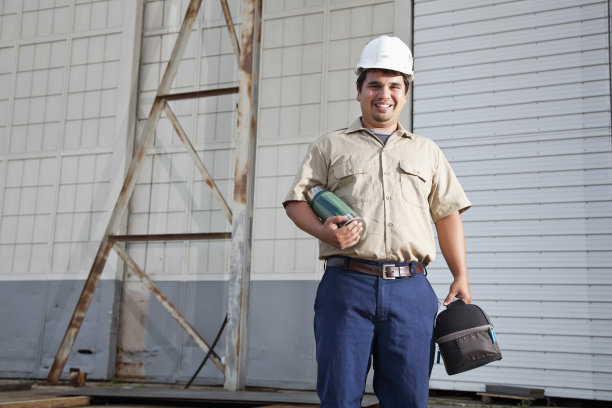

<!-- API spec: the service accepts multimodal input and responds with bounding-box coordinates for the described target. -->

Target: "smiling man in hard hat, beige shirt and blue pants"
[283,36,471,408]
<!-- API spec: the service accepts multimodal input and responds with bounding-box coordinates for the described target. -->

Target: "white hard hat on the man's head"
[357,35,414,82]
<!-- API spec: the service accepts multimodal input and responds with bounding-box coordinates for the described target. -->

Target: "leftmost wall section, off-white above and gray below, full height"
[0,0,142,378]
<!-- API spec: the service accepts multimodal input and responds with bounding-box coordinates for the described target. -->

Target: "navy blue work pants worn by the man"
[314,267,438,408]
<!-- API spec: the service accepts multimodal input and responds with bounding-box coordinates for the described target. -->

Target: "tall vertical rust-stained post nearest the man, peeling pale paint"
[224,0,263,391]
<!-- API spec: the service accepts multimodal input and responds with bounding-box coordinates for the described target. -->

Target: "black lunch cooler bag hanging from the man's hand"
[435,300,501,375]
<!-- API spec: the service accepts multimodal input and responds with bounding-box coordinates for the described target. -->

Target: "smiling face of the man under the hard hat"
[357,70,406,131]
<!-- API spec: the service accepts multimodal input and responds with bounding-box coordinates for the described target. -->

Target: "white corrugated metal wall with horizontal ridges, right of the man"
[414,0,612,400]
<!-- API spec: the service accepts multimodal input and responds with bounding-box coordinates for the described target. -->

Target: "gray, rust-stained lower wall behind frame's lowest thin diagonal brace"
[117,281,226,384]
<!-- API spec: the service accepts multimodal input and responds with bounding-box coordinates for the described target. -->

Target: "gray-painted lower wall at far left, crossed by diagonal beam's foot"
[0,280,117,379]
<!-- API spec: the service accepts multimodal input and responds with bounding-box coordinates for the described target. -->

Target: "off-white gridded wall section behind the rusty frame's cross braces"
[127,0,240,284]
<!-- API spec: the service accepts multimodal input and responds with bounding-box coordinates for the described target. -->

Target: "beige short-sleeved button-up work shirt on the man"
[283,118,471,265]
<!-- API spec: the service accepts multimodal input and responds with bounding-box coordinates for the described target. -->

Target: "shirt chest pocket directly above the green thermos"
[330,159,380,204]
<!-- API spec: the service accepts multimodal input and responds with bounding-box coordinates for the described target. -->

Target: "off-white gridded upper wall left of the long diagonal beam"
[0,0,140,280]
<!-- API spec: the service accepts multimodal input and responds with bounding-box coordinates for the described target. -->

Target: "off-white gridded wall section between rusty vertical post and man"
[253,0,402,280]
